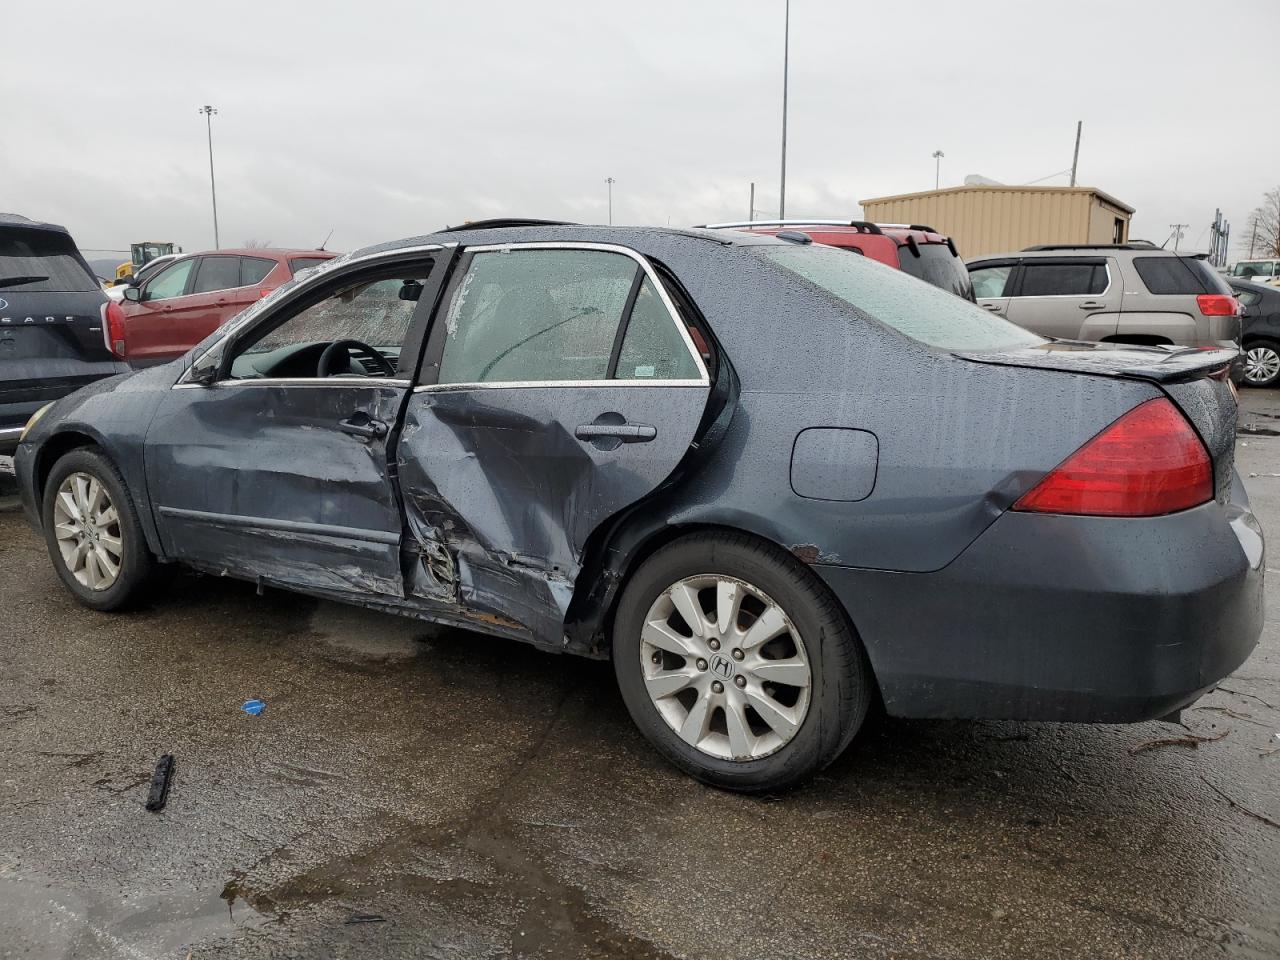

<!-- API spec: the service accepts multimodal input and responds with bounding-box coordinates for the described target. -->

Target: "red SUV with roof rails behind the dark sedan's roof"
[707,220,973,301]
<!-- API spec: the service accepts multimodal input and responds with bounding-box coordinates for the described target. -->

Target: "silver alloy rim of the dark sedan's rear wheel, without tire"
[640,573,813,760]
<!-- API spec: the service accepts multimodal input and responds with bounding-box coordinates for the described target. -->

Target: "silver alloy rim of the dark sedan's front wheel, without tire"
[54,472,124,590]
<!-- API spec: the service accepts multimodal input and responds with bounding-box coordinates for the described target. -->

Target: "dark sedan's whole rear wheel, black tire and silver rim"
[613,534,873,792]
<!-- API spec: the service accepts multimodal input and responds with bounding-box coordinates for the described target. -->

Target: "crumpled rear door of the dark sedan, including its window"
[396,244,709,645]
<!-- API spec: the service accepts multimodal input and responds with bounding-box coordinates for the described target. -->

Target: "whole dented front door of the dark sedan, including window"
[146,246,440,602]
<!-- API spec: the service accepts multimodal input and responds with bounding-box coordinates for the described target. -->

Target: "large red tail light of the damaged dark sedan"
[1014,397,1213,517]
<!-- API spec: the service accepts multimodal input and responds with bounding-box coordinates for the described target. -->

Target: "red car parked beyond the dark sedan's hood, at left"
[106,248,338,367]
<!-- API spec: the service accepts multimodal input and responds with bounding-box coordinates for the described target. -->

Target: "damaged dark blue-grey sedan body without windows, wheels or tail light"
[17,225,1263,747]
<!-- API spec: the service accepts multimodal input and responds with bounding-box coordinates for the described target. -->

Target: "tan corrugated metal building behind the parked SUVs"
[860,186,1133,259]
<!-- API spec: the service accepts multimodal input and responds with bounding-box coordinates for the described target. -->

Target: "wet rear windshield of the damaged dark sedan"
[751,244,1044,351]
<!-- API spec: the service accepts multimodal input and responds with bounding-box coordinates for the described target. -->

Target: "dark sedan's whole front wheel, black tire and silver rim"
[41,448,155,611]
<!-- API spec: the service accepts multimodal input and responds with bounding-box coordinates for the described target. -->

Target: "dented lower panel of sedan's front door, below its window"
[147,380,407,598]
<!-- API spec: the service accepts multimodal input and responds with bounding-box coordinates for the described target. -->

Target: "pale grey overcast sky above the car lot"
[0,0,1280,256]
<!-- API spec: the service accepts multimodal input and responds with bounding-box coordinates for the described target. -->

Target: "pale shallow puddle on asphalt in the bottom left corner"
[0,877,268,960]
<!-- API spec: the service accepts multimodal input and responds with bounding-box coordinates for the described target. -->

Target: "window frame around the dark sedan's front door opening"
[170,243,457,390]
